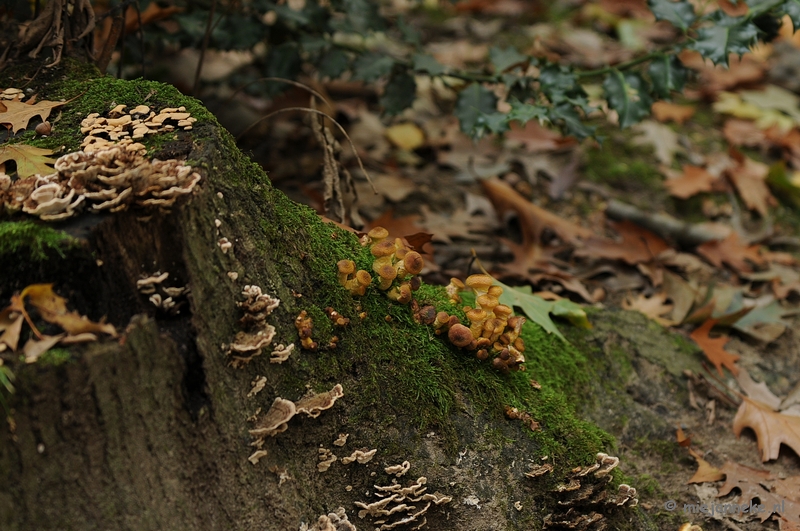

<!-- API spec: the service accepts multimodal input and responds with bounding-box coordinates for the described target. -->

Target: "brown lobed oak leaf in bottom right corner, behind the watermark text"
[717,461,800,531]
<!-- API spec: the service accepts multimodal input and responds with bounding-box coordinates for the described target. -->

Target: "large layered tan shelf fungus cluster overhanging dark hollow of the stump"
[7,145,201,221]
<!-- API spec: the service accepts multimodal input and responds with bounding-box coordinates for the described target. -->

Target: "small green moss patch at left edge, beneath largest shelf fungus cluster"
[0,221,78,262]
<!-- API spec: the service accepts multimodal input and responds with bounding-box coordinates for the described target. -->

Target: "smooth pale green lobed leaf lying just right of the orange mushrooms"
[495,280,592,343]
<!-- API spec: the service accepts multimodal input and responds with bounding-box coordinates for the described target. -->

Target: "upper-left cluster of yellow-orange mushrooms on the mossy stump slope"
[336,227,425,304]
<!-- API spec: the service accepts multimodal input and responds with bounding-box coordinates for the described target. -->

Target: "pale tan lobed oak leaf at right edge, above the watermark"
[733,397,800,462]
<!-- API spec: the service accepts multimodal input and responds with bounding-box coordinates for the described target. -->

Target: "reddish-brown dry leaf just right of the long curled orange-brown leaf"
[575,220,670,265]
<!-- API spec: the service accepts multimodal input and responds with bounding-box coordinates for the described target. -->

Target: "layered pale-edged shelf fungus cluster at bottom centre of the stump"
[355,476,453,531]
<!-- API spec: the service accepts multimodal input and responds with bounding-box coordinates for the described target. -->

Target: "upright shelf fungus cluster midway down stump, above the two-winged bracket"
[227,285,282,368]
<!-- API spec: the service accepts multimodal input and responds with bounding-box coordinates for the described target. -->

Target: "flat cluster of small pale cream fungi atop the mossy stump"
[81,105,197,151]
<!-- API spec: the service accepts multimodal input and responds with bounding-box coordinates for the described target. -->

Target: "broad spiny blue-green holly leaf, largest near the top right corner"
[690,11,758,66]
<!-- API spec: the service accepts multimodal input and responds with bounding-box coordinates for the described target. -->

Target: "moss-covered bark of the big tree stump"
[0,58,704,530]
